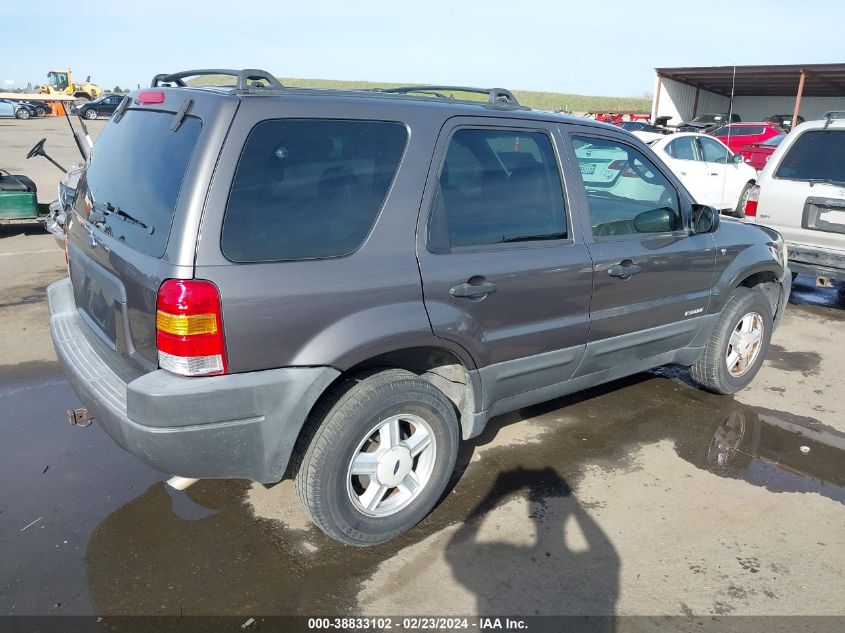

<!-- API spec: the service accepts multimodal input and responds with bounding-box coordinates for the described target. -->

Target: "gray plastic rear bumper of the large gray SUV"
[47,279,339,483]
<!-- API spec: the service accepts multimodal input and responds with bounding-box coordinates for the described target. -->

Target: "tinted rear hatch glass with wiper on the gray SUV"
[76,110,202,257]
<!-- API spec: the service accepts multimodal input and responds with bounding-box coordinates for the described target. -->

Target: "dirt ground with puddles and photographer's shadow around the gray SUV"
[0,120,845,630]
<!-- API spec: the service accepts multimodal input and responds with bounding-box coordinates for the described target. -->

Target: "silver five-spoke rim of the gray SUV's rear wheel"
[346,414,437,517]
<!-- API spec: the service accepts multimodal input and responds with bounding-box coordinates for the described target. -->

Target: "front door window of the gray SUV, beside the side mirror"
[572,136,683,238]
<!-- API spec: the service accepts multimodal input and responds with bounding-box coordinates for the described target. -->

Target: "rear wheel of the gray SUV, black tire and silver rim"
[292,369,459,547]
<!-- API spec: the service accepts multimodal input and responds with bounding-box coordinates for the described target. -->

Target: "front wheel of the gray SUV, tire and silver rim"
[690,287,774,394]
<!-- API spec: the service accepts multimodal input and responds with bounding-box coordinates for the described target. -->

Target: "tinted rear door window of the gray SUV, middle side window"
[429,128,567,252]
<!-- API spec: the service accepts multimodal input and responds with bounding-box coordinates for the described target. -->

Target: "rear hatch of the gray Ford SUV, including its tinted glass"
[68,89,238,370]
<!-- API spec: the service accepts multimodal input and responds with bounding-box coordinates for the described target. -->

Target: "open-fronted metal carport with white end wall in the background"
[652,64,845,125]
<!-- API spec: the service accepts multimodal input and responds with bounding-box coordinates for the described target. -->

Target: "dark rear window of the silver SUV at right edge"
[775,130,845,182]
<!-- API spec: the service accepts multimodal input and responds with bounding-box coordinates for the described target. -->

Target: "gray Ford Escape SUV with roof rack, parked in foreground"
[49,70,791,545]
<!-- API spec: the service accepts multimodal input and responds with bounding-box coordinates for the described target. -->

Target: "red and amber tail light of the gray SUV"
[156,279,229,376]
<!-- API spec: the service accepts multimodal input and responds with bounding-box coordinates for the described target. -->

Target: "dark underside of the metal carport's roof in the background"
[656,64,845,97]
